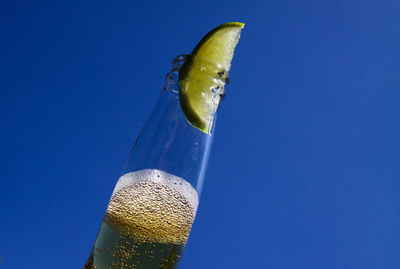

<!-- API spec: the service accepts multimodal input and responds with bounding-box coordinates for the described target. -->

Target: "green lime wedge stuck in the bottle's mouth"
[179,22,244,134]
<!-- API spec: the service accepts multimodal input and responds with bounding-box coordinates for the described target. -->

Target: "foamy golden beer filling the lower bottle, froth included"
[84,170,198,269]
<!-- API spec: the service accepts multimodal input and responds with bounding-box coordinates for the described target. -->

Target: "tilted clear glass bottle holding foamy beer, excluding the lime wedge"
[84,55,227,269]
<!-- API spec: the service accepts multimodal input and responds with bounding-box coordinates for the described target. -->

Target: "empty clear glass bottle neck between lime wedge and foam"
[123,56,225,194]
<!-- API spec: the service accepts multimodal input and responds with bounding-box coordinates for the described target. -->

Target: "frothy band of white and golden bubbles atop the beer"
[105,169,199,244]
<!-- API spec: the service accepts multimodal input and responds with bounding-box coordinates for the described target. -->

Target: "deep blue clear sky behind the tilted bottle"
[0,0,400,269]
